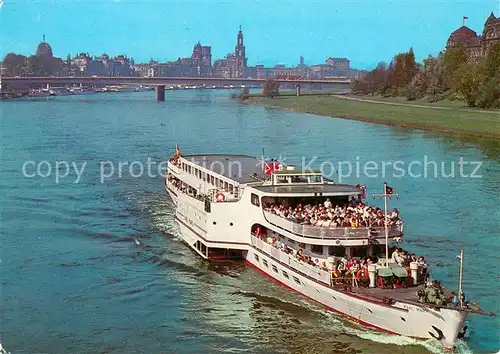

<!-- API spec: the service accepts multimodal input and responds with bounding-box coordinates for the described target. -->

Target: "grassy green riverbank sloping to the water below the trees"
[242,95,500,140]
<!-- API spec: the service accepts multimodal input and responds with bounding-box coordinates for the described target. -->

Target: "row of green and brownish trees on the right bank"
[352,43,500,108]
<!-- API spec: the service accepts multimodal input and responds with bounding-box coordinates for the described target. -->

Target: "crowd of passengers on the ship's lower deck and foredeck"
[253,227,427,286]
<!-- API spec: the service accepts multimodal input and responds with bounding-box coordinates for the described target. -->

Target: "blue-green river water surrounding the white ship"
[0,91,500,354]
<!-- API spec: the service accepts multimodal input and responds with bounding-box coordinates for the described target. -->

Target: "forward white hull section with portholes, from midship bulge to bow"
[246,247,468,348]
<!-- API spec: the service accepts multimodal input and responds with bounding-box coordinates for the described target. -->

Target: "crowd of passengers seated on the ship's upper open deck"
[264,199,403,228]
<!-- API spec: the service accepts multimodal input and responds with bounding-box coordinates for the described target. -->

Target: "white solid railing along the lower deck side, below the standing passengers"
[251,235,331,285]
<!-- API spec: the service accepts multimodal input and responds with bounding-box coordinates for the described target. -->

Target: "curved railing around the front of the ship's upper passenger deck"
[263,211,404,239]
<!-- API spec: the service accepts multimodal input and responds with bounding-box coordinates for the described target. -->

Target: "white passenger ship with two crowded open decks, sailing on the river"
[165,146,494,348]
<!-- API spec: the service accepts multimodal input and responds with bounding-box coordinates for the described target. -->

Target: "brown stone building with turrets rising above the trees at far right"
[446,12,500,60]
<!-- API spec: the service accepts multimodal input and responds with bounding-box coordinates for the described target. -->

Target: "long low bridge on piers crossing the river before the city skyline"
[0,76,351,101]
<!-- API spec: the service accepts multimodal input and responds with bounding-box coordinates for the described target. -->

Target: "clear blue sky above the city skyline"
[0,0,500,69]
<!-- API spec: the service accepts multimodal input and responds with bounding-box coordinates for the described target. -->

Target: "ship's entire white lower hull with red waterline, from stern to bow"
[165,174,468,348]
